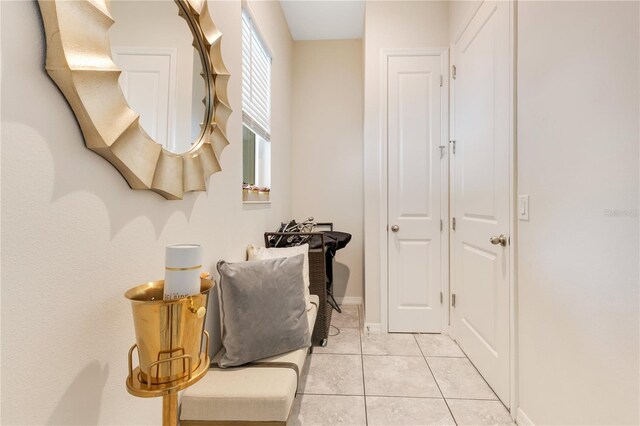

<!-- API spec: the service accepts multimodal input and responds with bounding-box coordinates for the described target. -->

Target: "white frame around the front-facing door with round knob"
[379,47,450,334]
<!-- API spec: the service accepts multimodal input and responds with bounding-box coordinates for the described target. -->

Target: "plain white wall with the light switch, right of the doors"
[517,1,640,425]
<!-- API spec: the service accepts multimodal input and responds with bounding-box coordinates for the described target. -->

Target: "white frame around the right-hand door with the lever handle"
[448,0,519,421]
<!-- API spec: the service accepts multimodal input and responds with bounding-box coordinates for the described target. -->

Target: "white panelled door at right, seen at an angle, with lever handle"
[451,1,511,405]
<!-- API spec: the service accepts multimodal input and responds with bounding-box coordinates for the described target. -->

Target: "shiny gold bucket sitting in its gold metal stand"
[125,278,215,426]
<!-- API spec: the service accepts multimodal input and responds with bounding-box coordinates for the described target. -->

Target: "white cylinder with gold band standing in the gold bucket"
[164,244,202,300]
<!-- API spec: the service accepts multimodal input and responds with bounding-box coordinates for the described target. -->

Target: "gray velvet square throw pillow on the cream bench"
[218,255,311,368]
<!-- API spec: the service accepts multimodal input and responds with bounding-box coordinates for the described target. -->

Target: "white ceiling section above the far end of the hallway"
[280,0,364,40]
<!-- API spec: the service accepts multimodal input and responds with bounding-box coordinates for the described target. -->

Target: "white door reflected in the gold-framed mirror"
[113,47,176,151]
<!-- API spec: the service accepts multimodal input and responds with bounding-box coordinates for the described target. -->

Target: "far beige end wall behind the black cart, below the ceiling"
[292,40,364,302]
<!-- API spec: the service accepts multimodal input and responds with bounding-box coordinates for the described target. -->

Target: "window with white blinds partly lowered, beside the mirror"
[242,10,271,201]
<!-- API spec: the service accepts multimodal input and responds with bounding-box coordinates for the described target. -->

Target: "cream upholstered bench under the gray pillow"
[180,295,319,426]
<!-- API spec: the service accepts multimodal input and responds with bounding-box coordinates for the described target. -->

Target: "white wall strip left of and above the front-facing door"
[364,0,449,329]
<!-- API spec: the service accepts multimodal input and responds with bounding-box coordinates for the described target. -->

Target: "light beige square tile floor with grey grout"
[288,305,514,426]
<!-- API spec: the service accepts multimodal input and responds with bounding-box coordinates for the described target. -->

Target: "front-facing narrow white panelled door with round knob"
[387,52,446,333]
